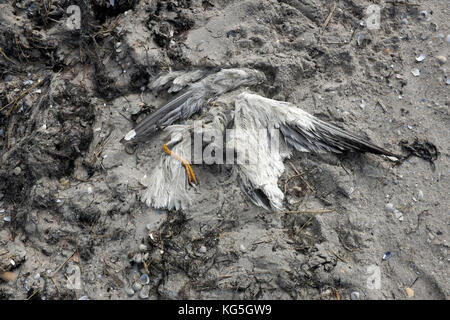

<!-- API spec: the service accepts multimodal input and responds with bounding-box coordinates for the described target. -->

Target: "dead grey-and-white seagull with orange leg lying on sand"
[121,68,399,211]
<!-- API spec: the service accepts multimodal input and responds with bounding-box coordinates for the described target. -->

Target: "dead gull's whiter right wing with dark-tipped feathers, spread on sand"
[232,92,396,209]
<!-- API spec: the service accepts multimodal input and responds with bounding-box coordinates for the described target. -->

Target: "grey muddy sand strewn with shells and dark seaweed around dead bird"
[0,0,450,299]
